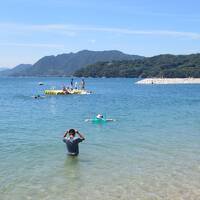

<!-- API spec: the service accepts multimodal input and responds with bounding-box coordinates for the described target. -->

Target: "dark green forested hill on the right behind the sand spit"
[74,54,200,78]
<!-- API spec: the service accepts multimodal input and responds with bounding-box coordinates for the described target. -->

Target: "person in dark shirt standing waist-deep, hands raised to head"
[63,129,85,156]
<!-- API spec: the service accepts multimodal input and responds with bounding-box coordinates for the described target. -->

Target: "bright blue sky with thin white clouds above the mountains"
[0,0,200,67]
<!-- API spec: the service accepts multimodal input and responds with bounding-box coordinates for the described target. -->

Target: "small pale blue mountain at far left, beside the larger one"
[0,64,32,76]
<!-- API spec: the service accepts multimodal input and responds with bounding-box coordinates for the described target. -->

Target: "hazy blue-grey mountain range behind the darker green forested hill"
[0,50,143,76]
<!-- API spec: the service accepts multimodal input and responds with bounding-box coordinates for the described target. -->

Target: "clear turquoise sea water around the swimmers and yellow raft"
[0,78,200,200]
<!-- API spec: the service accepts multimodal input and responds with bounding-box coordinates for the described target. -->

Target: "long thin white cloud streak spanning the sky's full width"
[0,23,200,39]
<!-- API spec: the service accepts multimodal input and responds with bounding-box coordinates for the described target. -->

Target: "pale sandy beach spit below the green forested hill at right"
[136,78,200,84]
